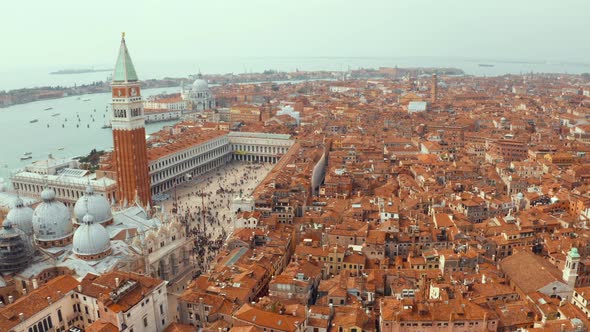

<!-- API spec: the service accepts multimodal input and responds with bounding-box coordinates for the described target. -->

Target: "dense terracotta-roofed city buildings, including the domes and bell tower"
[0,34,590,332]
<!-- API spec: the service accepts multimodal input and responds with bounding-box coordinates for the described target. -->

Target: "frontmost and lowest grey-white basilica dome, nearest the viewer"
[72,214,111,256]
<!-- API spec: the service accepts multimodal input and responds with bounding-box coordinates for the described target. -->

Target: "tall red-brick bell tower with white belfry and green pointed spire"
[111,33,151,206]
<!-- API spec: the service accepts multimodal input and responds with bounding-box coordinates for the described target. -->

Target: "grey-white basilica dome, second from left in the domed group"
[33,189,73,241]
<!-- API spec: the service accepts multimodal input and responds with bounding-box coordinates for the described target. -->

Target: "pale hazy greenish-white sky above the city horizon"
[0,0,590,71]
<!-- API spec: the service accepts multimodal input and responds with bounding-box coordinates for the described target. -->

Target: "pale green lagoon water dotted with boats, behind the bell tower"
[0,88,178,183]
